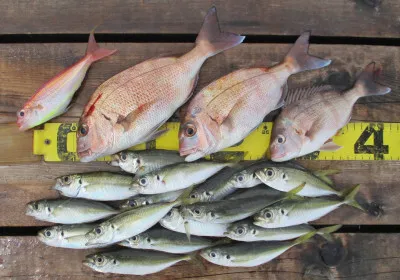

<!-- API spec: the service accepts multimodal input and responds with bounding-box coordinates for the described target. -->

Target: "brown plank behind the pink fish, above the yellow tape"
[0,43,400,120]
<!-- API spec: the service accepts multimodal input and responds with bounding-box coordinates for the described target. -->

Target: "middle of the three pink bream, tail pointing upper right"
[179,32,331,161]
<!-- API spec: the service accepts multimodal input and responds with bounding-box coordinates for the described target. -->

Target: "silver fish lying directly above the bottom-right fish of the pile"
[225,220,341,242]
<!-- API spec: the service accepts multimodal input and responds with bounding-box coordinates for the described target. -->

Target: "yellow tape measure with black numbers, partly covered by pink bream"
[33,122,400,161]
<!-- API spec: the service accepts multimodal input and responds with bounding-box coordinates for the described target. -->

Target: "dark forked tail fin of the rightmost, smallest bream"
[354,62,391,97]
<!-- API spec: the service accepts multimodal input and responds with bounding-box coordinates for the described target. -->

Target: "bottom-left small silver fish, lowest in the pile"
[83,249,191,275]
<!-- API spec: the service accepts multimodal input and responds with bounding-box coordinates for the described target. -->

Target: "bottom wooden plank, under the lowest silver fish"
[0,234,400,280]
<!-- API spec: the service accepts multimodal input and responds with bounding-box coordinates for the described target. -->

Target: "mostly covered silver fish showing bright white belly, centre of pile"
[160,208,230,237]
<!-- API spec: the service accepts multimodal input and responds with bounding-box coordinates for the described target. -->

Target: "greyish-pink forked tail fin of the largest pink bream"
[196,7,245,57]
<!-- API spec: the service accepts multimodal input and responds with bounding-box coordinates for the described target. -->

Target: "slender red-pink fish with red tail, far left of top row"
[17,32,117,131]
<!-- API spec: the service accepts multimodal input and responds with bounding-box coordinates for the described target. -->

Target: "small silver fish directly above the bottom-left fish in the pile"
[118,228,215,254]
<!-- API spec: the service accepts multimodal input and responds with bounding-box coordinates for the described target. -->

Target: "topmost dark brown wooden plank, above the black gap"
[0,0,400,37]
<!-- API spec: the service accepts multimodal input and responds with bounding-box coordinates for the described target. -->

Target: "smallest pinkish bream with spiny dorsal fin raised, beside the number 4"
[270,62,391,161]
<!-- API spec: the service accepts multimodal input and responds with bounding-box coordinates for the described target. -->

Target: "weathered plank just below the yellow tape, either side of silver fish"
[0,161,400,227]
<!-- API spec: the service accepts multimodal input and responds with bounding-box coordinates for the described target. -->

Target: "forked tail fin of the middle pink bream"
[285,32,332,73]
